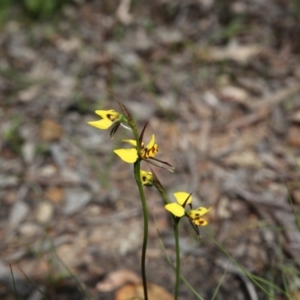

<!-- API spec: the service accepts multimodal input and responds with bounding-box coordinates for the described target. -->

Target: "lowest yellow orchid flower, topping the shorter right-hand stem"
[165,192,210,226]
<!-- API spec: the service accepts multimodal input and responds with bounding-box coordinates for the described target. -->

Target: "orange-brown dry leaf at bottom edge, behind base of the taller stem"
[115,283,173,300]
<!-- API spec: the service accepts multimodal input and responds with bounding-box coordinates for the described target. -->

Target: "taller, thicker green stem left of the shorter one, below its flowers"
[134,159,148,300]
